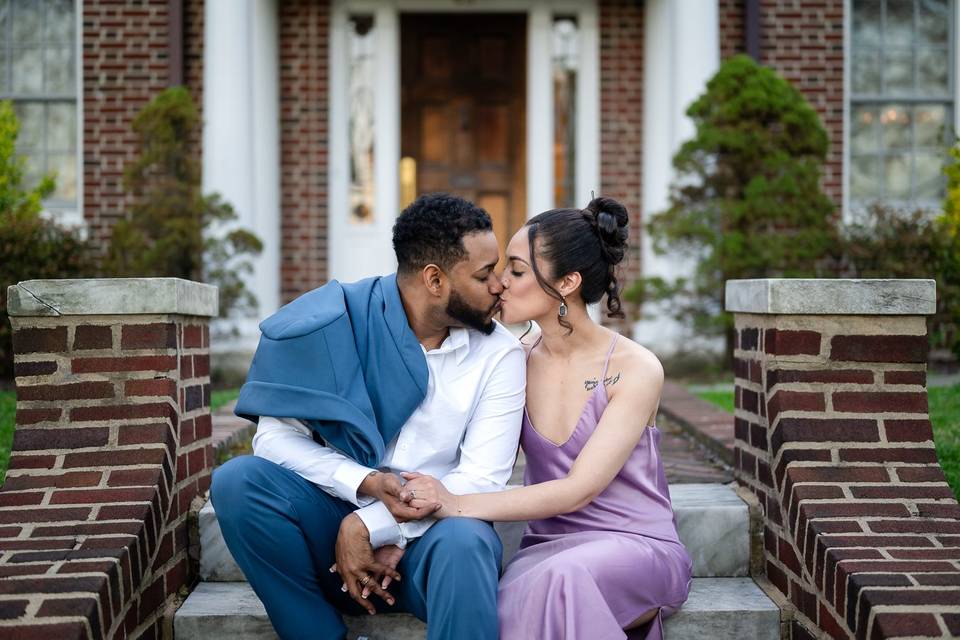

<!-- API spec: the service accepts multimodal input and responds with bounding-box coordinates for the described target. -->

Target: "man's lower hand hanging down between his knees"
[330,513,400,615]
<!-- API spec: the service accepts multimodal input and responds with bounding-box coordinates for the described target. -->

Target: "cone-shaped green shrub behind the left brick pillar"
[103,87,262,317]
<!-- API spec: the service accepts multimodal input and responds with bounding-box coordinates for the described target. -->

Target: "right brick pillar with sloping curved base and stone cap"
[727,279,960,640]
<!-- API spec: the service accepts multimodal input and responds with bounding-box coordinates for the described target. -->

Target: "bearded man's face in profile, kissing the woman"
[446,231,503,335]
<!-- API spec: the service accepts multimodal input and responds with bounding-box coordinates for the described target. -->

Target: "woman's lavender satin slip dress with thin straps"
[498,336,692,640]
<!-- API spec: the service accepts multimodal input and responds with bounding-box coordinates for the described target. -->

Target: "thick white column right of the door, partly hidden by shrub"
[634,0,720,355]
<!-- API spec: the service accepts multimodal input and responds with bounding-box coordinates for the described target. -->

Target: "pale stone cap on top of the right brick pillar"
[726,278,937,315]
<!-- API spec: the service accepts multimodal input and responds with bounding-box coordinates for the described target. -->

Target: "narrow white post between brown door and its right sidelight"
[526,3,554,218]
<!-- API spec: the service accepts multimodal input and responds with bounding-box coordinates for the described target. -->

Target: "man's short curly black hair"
[393,193,493,273]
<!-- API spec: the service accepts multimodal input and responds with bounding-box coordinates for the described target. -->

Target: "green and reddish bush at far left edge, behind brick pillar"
[0,101,94,379]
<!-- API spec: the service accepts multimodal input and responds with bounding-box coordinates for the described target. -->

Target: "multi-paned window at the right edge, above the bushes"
[848,0,955,207]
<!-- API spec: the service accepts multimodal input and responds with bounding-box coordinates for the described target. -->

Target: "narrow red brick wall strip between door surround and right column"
[597,0,644,320]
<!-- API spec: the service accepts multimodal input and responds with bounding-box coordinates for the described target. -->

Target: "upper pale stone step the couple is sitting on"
[199,484,750,582]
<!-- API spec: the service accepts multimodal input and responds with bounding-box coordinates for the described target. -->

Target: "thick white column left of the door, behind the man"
[203,0,280,352]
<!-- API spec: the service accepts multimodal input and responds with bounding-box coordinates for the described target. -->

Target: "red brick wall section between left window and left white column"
[82,0,203,248]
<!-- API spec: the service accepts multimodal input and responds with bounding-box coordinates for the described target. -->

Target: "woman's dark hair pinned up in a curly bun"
[526,198,629,331]
